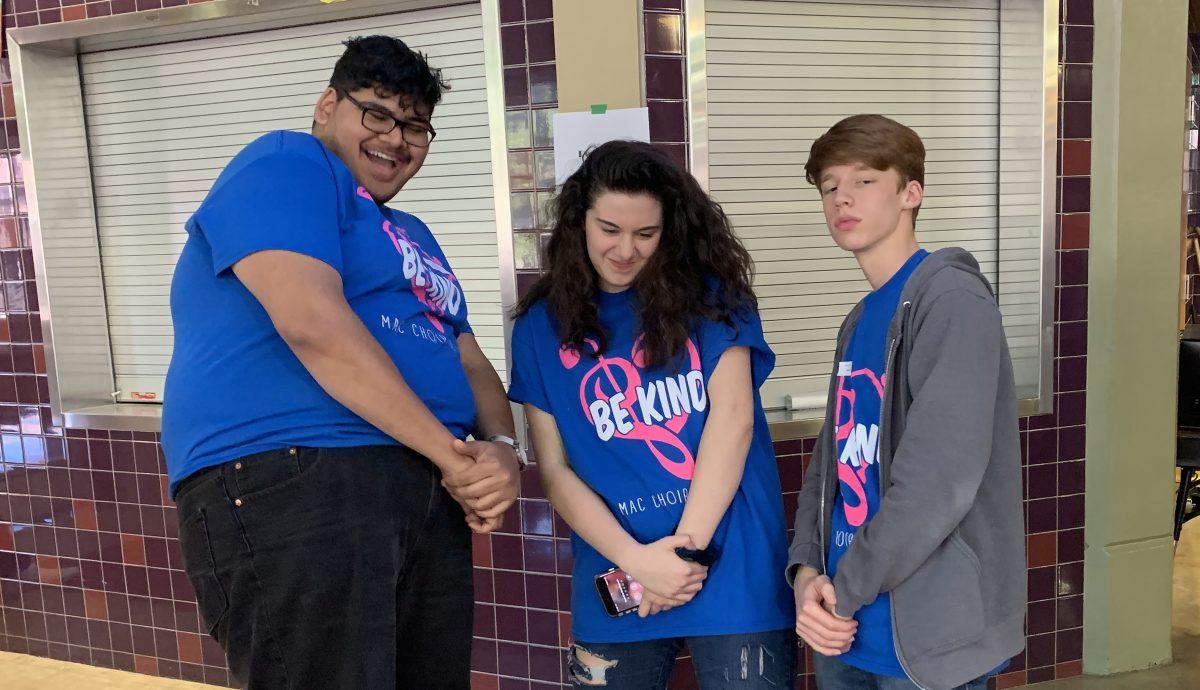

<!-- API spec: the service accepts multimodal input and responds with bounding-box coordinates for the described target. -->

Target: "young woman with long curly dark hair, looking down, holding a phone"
[509,142,797,690]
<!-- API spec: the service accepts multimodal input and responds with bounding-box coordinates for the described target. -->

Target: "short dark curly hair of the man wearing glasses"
[329,36,450,110]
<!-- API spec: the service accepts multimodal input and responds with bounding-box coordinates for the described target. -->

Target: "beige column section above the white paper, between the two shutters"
[554,0,644,113]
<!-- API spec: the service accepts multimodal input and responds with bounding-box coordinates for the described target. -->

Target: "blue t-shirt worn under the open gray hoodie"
[829,250,929,678]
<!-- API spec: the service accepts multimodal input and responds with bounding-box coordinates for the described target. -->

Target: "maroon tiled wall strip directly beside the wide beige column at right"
[994,0,1093,688]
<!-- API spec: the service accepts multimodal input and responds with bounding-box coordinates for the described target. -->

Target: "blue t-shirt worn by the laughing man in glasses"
[162,132,475,493]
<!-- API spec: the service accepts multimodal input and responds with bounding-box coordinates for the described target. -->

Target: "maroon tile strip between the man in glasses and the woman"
[472,0,561,690]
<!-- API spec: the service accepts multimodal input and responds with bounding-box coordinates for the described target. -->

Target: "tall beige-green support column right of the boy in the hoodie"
[1084,0,1188,674]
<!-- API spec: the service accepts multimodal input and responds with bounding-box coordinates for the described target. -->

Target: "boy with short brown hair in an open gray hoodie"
[787,115,1026,690]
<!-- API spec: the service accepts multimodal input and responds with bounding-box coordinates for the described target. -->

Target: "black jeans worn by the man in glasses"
[175,446,474,689]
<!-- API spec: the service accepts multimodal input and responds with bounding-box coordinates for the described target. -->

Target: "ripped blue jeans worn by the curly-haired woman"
[566,630,797,690]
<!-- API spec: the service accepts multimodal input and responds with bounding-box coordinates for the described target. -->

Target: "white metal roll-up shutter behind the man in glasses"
[80,4,506,401]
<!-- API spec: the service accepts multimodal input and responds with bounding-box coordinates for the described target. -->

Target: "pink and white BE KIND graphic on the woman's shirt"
[558,338,708,480]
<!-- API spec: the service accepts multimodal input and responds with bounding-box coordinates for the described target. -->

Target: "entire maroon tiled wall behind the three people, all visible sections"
[0,0,1092,690]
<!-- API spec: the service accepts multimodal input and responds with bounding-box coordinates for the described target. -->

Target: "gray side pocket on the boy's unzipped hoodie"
[893,533,984,659]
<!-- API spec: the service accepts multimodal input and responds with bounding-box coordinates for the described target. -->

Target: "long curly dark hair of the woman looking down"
[512,136,758,367]
